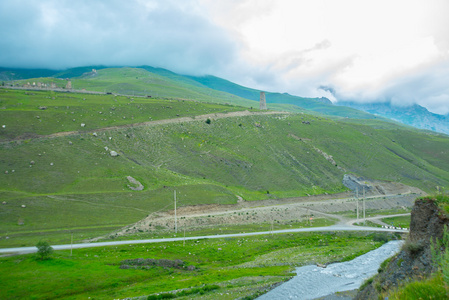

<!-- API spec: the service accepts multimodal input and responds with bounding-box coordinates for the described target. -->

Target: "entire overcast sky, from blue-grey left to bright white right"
[0,0,449,114]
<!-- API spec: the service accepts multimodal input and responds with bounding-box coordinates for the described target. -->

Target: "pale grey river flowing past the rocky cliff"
[257,241,402,300]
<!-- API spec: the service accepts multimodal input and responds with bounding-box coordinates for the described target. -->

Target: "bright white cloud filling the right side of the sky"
[203,0,449,112]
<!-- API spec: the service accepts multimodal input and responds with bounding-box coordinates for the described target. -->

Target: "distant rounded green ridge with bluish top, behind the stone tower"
[3,66,386,119]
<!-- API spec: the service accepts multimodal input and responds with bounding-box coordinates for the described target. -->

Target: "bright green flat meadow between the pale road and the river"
[0,233,382,299]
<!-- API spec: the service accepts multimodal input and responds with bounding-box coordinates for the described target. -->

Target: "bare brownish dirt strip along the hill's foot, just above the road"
[107,193,417,235]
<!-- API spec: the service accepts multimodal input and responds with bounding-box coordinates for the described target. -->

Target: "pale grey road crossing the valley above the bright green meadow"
[0,225,407,254]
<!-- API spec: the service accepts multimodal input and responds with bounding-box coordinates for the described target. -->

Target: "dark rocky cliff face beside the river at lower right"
[355,198,449,299]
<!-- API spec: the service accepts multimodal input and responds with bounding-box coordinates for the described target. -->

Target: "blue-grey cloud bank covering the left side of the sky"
[0,0,237,74]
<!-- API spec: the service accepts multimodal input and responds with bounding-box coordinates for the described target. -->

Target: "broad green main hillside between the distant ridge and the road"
[0,89,449,245]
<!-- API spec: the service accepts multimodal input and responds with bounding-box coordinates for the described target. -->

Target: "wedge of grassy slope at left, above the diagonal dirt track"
[0,89,243,142]
